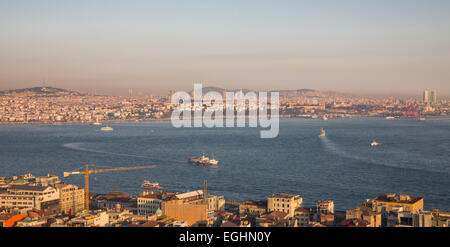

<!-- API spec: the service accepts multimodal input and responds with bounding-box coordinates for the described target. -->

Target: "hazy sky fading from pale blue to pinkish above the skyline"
[0,0,450,96]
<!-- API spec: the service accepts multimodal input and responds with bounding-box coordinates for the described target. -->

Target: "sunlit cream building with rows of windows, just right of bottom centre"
[267,193,303,217]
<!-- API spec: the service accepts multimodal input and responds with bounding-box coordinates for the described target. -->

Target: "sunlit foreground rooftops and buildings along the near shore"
[0,174,450,227]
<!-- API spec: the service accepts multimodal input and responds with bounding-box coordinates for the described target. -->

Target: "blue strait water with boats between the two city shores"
[0,118,450,210]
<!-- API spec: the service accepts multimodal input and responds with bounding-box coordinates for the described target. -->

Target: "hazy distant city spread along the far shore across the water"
[0,87,450,124]
